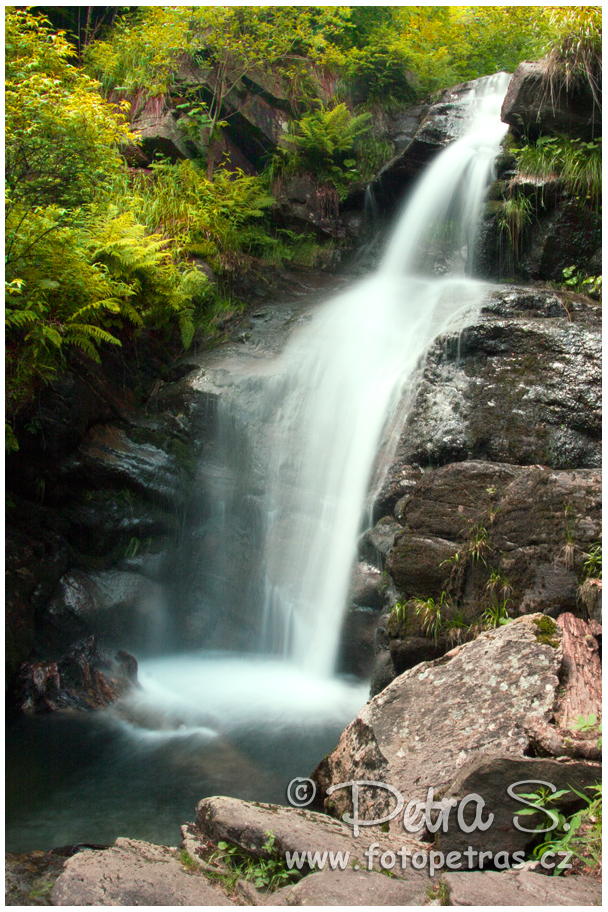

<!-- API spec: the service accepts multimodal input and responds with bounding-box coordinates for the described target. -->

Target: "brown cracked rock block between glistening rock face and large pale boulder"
[386,462,601,616]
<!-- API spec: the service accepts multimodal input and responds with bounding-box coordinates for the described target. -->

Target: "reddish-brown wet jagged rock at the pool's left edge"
[16,637,137,712]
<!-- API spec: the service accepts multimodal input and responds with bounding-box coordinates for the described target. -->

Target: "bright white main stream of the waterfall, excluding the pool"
[262,74,508,675]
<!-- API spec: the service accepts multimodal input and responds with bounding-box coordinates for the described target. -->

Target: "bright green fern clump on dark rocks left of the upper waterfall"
[273,103,370,197]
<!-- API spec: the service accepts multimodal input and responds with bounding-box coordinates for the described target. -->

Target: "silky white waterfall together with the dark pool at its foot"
[7,75,508,851]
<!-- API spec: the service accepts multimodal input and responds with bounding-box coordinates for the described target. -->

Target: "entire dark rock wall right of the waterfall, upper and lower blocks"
[359,288,601,693]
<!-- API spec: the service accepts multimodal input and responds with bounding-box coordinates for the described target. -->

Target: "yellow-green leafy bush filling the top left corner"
[5,7,131,217]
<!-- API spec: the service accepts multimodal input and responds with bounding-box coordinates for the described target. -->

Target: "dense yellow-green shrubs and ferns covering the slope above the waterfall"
[6,6,599,448]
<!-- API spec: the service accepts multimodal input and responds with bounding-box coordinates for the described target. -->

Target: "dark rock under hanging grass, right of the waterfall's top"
[501,61,602,139]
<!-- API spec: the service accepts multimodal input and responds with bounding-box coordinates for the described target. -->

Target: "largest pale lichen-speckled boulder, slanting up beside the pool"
[312,615,576,839]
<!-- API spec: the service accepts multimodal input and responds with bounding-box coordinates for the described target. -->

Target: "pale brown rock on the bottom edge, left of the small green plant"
[51,839,234,906]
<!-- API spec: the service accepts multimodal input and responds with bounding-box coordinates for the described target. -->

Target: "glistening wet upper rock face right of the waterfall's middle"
[388,288,601,474]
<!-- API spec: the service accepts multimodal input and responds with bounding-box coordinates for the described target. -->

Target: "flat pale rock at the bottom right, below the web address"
[443,871,602,908]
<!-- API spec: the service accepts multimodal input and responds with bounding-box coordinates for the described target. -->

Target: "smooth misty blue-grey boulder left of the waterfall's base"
[44,570,165,649]
